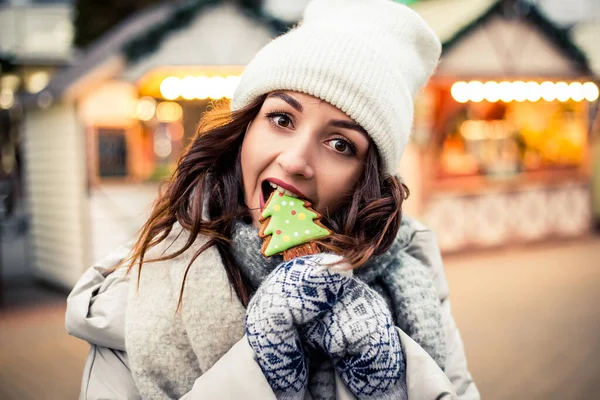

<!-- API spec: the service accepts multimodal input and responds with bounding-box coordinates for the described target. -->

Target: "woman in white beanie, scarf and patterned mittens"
[67,0,478,399]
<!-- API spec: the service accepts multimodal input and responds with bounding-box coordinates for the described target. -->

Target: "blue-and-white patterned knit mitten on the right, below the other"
[301,278,408,399]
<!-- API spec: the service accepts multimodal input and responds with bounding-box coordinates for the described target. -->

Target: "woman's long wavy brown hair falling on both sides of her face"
[126,95,409,308]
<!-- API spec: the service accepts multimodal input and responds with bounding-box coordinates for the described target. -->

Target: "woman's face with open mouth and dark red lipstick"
[241,91,370,226]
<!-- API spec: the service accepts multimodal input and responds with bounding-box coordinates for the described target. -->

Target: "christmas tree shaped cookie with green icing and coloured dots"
[258,190,331,261]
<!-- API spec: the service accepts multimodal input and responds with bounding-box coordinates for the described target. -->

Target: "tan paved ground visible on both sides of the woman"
[0,227,600,400]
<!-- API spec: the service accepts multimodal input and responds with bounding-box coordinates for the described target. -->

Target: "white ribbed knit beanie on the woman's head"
[232,0,441,175]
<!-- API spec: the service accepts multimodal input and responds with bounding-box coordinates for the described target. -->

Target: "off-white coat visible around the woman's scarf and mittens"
[65,217,480,400]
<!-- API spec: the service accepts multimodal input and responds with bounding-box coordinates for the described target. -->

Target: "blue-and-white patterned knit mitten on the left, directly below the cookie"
[246,254,352,399]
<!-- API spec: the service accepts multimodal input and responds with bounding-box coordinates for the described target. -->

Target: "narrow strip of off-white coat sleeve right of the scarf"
[406,220,481,400]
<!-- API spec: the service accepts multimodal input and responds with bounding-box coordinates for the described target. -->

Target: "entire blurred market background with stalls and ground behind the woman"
[0,0,600,399]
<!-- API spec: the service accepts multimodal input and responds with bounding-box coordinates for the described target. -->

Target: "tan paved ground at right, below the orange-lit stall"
[446,237,600,400]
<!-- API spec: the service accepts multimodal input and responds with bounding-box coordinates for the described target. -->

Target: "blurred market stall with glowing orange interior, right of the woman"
[404,0,598,251]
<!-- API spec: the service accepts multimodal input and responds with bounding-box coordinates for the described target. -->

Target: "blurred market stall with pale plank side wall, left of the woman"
[17,0,292,287]
